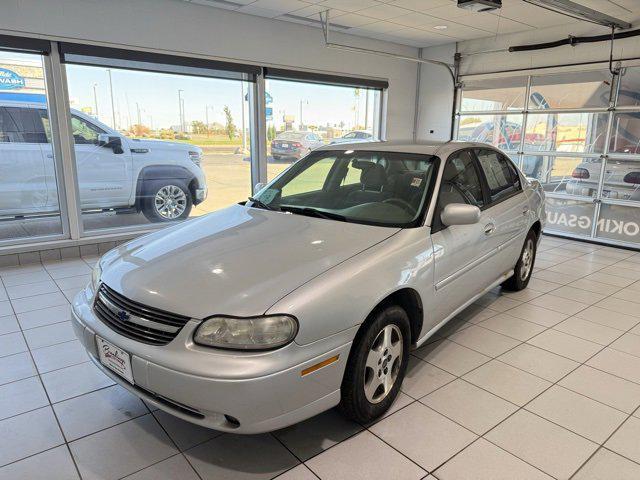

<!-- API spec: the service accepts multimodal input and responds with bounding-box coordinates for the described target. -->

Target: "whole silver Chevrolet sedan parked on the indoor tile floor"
[72,142,545,433]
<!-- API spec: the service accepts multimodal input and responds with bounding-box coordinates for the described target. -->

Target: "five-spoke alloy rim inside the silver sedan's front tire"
[364,324,403,403]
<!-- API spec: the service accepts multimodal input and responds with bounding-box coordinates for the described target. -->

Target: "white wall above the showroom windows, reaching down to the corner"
[0,0,417,139]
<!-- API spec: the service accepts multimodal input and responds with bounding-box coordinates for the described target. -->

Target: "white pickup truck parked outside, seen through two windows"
[0,100,207,222]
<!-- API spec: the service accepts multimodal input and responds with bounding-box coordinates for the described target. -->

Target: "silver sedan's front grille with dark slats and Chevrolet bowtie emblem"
[93,284,189,345]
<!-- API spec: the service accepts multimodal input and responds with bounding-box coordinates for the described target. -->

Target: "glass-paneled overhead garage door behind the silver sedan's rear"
[457,66,640,246]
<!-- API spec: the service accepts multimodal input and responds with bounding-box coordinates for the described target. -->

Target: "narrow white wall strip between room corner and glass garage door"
[416,44,456,141]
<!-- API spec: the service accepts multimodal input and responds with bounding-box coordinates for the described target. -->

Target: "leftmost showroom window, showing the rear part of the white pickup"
[0,36,65,245]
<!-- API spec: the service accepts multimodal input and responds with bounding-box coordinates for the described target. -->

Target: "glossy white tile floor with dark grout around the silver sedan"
[0,237,640,480]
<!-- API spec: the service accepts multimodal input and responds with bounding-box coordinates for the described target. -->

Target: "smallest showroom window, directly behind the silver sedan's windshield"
[265,69,386,180]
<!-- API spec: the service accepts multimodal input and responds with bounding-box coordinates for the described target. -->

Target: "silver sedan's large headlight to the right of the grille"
[193,315,298,350]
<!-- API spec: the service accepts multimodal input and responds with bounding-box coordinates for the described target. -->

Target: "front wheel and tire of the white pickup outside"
[142,179,193,223]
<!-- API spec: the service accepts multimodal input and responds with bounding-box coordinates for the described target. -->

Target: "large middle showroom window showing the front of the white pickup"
[62,44,255,233]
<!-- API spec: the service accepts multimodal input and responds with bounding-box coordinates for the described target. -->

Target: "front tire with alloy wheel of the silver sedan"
[338,305,411,423]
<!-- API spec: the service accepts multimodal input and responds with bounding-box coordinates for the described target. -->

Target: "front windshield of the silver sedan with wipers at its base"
[252,150,437,227]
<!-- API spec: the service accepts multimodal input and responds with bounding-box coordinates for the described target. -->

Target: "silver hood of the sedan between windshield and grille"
[102,205,399,318]
